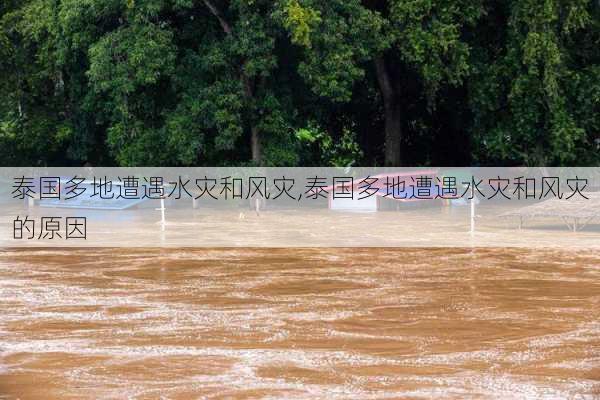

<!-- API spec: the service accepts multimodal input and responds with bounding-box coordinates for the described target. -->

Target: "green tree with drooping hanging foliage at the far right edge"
[470,0,600,165]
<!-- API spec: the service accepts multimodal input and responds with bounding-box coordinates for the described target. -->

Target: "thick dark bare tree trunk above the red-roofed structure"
[375,56,402,167]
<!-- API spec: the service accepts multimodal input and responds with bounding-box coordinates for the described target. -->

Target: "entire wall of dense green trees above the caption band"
[0,0,600,166]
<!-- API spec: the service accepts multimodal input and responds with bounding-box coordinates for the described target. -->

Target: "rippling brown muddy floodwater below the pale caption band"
[0,248,600,400]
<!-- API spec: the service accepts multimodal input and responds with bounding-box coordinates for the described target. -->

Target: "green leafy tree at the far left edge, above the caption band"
[0,1,72,165]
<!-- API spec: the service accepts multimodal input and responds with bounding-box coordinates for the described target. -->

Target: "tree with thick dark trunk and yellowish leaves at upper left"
[284,0,483,165]
